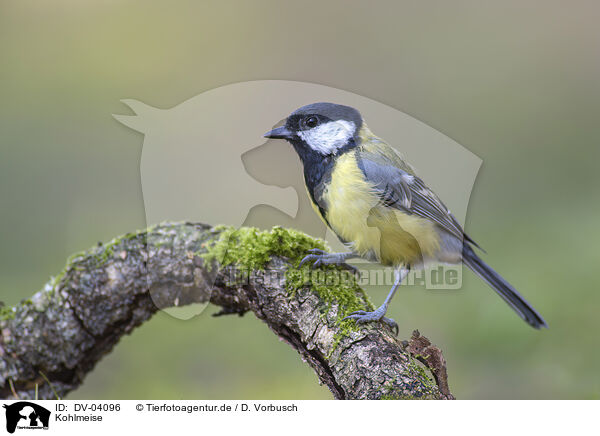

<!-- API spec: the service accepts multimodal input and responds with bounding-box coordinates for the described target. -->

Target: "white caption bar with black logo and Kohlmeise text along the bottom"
[0,400,600,436]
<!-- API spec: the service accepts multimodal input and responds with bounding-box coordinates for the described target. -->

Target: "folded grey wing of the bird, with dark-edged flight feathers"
[357,153,471,242]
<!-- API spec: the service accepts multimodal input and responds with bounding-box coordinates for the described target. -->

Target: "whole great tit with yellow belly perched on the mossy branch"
[264,103,547,329]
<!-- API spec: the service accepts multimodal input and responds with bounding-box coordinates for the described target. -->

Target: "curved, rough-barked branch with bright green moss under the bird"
[0,223,451,399]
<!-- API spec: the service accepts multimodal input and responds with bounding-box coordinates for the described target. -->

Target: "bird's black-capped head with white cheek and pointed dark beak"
[264,103,363,156]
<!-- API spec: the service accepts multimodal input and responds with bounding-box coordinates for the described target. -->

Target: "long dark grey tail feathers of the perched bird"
[463,243,548,329]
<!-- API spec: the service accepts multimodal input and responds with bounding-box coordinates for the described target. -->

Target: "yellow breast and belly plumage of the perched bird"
[323,153,439,266]
